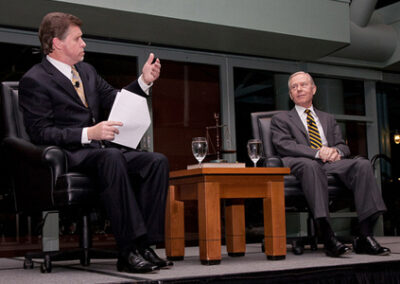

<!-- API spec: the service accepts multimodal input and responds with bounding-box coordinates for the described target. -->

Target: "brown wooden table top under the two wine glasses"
[169,167,290,178]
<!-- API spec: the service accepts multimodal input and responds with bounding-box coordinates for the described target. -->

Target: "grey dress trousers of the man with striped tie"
[283,157,386,221]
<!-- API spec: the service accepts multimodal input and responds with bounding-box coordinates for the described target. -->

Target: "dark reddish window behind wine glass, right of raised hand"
[152,60,220,170]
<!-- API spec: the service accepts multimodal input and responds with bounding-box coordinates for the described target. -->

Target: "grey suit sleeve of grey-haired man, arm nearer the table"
[271,115,317,159]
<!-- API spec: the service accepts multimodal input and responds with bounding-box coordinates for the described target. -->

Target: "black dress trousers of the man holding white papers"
[71,148,169,249]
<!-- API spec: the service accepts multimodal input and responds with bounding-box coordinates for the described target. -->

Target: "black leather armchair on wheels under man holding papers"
[1,82,117,272]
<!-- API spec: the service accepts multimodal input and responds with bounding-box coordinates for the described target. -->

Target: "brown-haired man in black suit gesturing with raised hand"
[19,13,172,273]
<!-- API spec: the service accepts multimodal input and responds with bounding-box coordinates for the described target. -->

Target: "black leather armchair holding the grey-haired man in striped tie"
[251,111,352,254]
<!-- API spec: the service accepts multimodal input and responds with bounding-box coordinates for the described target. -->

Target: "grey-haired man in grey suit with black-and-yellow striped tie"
[271,72,390,257]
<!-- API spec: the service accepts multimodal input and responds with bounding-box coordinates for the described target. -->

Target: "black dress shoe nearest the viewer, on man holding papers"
[117,250,158,273]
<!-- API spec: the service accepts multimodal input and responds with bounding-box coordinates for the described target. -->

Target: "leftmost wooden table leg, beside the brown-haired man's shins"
[165,185,185,260]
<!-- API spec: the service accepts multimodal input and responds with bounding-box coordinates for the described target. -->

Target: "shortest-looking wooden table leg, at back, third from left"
[225,199,246,256]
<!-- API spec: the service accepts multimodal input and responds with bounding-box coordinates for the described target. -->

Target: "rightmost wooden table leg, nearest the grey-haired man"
[264,180,286,260]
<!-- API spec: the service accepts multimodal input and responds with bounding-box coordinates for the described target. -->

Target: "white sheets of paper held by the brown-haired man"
[108,89,151,149]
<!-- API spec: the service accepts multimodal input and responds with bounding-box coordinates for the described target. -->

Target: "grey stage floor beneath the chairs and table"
[0,237,400,284]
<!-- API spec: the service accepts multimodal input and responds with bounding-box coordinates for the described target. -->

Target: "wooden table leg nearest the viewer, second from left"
[197,182,221,265]
